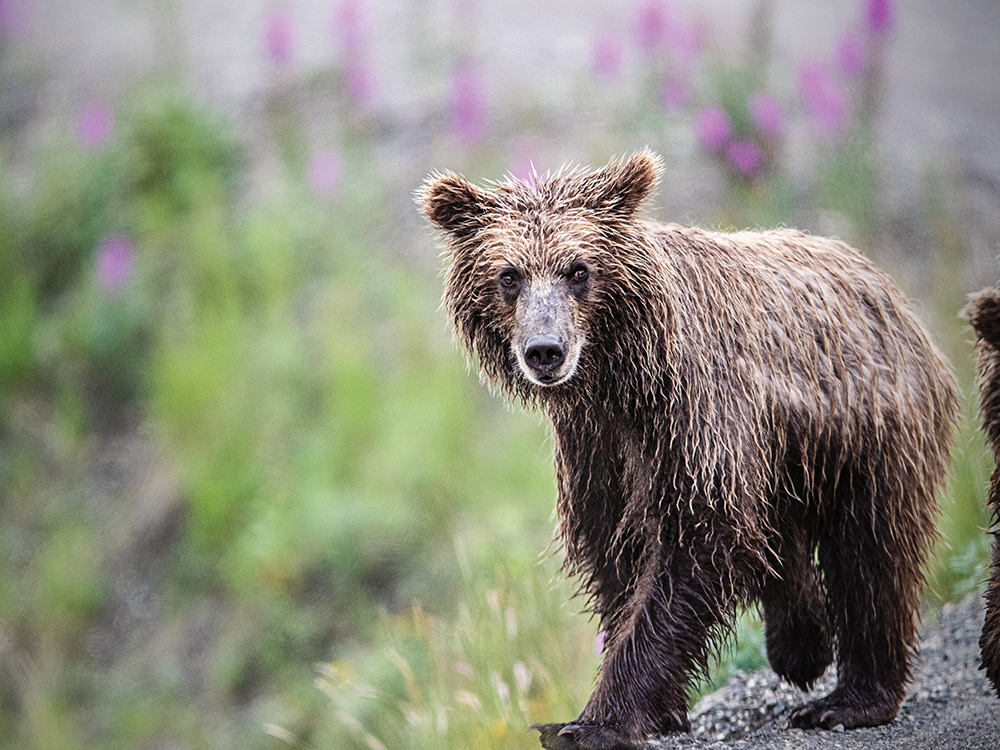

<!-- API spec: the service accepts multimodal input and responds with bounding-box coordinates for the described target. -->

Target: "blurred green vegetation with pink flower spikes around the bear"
[0,3,989,750]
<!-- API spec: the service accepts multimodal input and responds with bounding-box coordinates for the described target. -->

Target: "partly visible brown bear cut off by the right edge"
[965,289,1000,695]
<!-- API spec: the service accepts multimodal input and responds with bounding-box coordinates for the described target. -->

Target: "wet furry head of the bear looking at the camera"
[420,152,660,398]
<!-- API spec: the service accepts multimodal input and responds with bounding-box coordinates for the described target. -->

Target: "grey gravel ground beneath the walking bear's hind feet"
[649,595,1000,750]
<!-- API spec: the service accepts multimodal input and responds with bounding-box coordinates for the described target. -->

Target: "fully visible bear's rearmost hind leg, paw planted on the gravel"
[789,472,920,729]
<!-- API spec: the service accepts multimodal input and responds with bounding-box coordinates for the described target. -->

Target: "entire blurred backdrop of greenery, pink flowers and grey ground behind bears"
[0,0,1000,750]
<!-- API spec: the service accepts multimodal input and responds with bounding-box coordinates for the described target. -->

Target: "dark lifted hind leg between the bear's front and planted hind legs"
[761,530,833,690]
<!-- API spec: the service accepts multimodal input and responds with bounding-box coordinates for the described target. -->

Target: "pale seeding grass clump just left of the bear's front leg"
[308,558,597,750]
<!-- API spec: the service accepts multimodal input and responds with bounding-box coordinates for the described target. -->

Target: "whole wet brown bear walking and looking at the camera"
[419,152,957,750]
